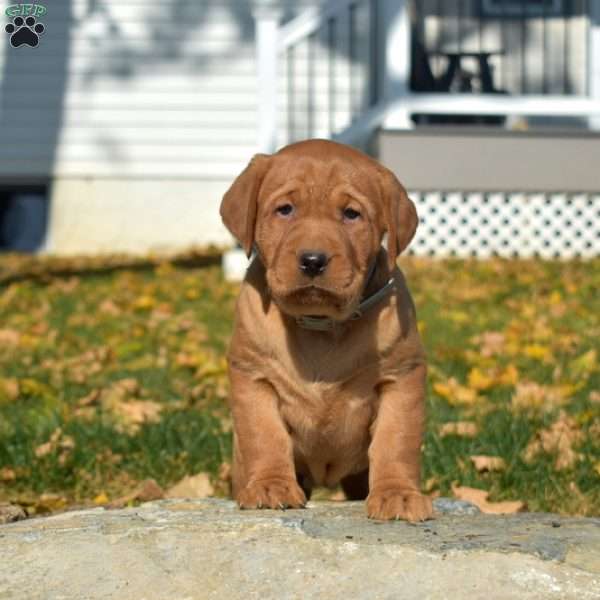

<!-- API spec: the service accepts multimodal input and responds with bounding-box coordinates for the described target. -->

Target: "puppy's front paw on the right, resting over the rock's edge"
[367,487,433,523]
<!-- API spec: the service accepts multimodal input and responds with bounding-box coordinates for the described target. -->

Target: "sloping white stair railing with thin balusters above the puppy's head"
[256,0,381,150]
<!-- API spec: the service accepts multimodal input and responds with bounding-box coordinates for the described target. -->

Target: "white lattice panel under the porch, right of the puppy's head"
[410,192,600,258]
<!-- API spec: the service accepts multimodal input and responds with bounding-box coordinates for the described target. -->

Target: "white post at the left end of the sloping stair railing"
[253,2,281,153]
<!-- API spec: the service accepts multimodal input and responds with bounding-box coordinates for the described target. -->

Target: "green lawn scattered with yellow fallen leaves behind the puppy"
[0,258,600,515]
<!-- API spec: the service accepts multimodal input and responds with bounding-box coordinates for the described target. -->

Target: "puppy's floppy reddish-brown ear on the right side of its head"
[381,169,419,270]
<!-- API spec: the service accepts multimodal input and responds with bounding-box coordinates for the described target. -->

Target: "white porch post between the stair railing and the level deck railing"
[381,0,413,129]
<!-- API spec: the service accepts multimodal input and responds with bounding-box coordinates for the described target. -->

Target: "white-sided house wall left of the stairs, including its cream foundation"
[0,0,324,253]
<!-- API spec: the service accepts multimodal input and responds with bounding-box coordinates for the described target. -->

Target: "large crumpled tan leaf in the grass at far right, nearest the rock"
[521,410,584,471]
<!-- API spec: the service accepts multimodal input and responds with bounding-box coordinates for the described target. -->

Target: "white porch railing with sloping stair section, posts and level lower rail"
[256,0,600,151]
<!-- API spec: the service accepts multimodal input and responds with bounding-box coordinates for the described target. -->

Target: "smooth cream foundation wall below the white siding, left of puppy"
[45,178,233,254]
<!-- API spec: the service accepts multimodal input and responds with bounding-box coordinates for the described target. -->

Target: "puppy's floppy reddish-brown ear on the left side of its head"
[220,154,270,257]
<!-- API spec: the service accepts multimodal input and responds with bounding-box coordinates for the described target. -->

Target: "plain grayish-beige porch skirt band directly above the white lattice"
[377,127,600,193]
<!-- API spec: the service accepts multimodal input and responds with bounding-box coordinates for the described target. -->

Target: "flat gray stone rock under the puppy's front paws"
[0,499,600,600]
